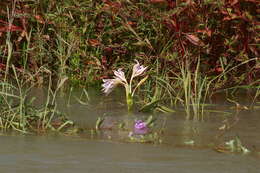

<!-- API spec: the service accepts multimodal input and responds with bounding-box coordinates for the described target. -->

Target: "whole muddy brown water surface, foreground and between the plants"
[0,88,260,173]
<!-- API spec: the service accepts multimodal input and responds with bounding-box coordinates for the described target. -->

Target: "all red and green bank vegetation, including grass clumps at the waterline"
[0,0,260,132]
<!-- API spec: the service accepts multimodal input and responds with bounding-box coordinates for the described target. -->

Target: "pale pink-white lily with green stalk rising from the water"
[102,60,148,112]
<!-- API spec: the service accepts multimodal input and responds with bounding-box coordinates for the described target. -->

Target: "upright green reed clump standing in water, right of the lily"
[172,56,209,120]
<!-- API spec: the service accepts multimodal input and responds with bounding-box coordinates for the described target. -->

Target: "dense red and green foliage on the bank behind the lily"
[0,0,260,100]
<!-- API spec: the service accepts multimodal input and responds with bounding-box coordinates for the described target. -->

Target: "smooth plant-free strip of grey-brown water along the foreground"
[0,136,260,173]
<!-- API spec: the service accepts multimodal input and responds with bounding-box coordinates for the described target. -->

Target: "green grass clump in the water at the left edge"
[0,66,73,133]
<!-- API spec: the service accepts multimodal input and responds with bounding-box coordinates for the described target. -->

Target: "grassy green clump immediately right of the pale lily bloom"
[138,60,178,113]
